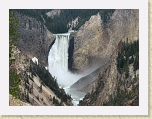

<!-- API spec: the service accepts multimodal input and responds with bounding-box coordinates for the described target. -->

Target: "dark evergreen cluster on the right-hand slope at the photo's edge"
[117,39,139,78]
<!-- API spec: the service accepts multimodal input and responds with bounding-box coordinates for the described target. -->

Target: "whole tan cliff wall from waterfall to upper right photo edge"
[72,9,139,71]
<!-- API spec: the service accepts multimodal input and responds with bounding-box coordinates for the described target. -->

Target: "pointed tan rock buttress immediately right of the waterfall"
[72,14,109,71]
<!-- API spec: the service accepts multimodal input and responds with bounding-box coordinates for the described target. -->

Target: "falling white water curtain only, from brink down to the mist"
[48,33,70,73]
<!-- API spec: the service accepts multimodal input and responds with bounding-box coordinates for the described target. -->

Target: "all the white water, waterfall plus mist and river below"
[48,33,85,105]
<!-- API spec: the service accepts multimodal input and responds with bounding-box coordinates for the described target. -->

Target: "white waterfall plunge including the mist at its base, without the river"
[48,33,70,87]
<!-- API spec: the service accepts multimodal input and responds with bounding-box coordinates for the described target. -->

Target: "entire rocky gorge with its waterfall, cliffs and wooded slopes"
[8,9,139,106]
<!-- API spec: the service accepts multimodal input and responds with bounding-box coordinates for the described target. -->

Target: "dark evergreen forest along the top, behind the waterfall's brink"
[14,9,114,33]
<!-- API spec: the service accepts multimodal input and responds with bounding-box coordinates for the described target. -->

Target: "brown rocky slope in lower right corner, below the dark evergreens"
[79,48,139,106]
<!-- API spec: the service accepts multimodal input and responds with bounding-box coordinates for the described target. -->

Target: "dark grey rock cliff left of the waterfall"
[16,13,55,66]
